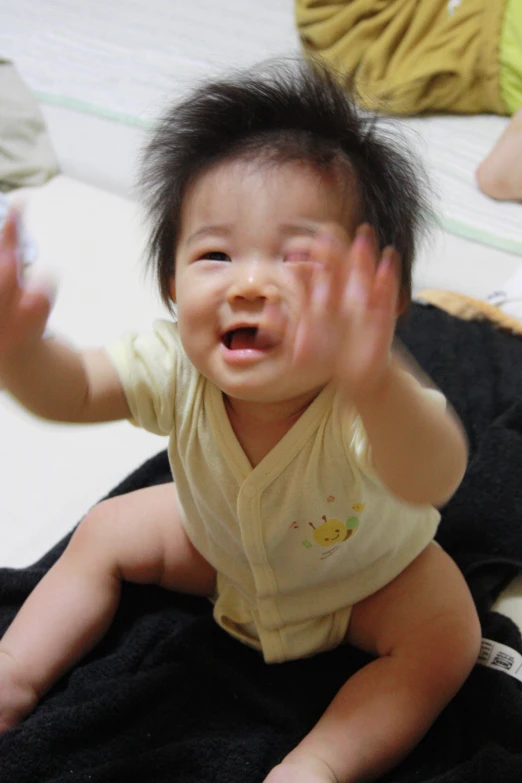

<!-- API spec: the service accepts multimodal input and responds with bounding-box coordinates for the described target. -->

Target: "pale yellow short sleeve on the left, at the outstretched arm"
[105,321,182,435]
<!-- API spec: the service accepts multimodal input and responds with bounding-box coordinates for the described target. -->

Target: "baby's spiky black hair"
[140,60,429,306]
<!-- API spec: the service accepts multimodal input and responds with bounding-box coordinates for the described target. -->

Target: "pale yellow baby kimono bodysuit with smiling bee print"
[107,321,442,662]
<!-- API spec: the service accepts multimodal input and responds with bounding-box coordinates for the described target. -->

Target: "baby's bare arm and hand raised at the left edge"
[0,213,130,422]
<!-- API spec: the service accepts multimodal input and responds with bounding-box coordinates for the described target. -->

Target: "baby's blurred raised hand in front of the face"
[288,224,400,400]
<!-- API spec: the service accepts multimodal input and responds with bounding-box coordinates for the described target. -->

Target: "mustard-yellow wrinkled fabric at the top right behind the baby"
[295,0,506,115]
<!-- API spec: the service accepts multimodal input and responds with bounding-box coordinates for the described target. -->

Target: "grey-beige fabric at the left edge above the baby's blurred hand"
[0,59,59,191]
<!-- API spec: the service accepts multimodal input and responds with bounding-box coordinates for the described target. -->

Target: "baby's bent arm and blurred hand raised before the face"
[286,225,467,506]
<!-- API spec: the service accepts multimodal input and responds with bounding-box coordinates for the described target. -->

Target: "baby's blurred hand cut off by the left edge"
[0,211,51,367]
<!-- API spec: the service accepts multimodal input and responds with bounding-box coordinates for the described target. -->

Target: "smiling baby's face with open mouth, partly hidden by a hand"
[171,160,352,410]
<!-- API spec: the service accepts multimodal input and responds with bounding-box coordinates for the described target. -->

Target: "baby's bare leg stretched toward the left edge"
[0,484,215,733]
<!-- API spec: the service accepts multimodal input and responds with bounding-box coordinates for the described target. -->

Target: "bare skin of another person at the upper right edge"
[477,107,522,201]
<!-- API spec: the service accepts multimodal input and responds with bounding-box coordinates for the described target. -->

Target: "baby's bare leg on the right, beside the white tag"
[266,544,481,783]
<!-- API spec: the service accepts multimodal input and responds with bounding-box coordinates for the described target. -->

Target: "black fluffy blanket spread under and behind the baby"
[0,305,522,783]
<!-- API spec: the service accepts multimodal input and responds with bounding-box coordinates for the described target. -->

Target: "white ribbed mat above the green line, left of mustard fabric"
[0,0,298,126]
